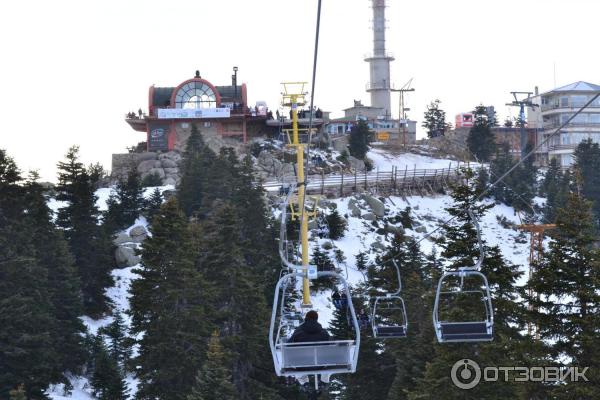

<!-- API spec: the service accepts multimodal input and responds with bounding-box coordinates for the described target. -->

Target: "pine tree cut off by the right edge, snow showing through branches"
[529,193,600,399]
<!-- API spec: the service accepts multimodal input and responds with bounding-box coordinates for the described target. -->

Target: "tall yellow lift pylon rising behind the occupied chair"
[281,82,316,307]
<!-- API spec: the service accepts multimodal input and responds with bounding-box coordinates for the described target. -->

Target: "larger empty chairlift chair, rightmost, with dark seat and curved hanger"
[433,210,494,343]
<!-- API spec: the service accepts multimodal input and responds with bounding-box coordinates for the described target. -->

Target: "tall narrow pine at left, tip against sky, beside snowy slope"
[56,146,114,317]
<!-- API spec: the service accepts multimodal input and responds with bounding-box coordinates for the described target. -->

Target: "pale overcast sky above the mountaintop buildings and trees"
[0,0,600,181]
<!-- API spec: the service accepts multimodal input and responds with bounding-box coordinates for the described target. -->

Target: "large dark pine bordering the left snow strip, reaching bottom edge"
[130,198,210,400]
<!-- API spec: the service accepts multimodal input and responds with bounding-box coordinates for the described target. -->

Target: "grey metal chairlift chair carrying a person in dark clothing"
[269,272,360,378]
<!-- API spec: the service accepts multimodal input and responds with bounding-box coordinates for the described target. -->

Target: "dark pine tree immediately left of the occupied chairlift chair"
[199,203,273,399]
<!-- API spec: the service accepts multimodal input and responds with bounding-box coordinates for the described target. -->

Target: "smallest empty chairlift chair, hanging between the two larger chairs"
[371,259,408,339]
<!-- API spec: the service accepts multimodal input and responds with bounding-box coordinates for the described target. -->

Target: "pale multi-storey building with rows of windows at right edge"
[528,81,600,167]
